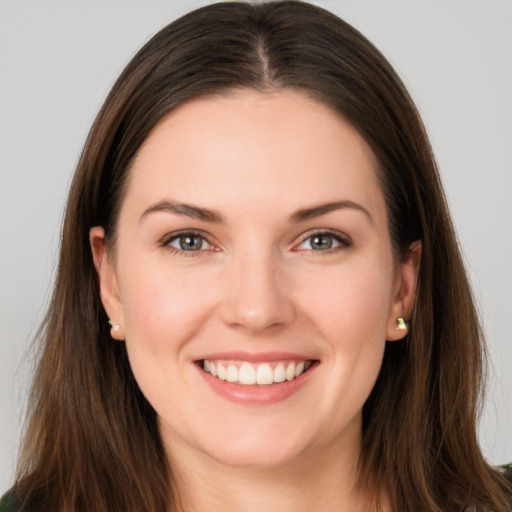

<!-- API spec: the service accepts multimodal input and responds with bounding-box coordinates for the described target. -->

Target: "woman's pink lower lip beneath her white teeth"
[195,361,318,404]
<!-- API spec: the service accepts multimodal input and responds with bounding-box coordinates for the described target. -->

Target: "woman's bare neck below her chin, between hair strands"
[162,428,382,512]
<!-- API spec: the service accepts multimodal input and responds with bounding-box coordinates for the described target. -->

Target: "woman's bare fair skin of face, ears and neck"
[90,90,420,512]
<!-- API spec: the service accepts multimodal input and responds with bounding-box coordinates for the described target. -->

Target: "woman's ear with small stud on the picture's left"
[89,226,124,340]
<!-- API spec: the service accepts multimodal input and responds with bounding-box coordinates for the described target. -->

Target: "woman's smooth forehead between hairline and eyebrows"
[125,90,382,222]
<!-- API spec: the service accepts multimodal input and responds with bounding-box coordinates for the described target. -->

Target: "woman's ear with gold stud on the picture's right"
[386,240,422,341]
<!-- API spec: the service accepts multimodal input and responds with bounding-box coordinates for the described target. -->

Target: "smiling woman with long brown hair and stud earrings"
[2,2,510,512]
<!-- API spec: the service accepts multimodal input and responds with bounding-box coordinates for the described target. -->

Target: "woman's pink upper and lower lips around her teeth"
[196,352,319,404]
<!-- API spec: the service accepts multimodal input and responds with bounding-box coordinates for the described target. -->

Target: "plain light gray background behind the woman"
[0,0,512,493]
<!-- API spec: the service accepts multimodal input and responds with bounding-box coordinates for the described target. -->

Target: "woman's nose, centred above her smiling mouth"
[223,249,295,335]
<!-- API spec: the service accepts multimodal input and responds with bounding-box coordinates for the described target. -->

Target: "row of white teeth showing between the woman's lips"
[198,359,316,386]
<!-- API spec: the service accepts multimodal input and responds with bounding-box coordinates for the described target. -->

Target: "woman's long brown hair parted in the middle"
[15,1,507,512]
